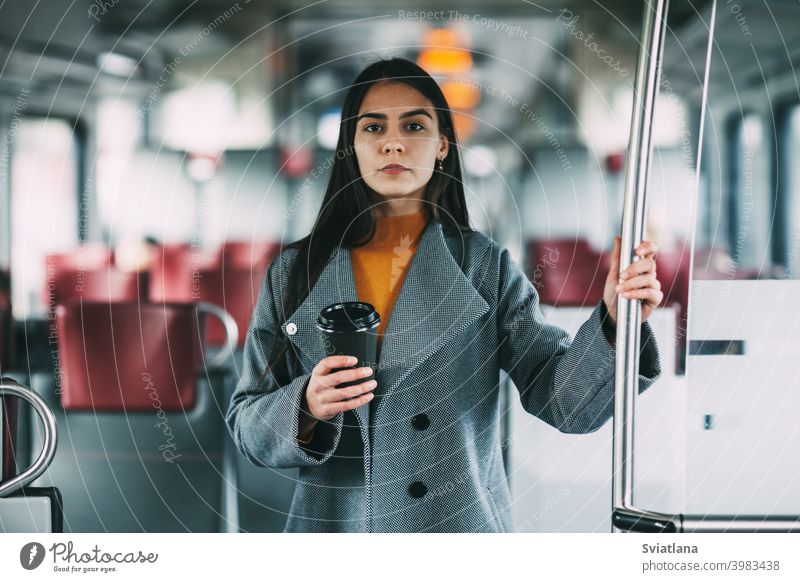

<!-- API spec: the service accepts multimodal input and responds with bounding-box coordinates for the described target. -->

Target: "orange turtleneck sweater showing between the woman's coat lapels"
[350,210,427,353]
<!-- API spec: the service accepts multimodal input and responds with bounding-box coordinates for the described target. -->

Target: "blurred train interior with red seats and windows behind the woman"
[0,0,800,532]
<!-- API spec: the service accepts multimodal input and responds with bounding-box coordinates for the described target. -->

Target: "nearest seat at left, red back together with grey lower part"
[32,303,227,532]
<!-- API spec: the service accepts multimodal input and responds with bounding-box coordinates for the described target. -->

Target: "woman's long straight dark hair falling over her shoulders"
[264,58,473,378]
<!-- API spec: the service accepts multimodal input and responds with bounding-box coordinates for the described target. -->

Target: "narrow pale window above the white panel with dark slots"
[727,113,772,279]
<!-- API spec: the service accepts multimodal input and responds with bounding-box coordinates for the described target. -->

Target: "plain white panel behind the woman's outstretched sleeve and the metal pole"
[509,307,686,533]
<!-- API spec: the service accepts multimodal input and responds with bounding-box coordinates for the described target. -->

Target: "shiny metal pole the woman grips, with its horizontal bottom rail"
[611,0,800,533]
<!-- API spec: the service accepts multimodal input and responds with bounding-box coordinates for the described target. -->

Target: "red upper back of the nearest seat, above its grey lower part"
[56,302,203,412]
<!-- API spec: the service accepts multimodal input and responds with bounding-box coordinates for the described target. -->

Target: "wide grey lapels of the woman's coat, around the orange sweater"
[281,219,489,434]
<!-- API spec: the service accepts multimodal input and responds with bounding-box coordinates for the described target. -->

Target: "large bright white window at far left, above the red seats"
[11,117,81,319]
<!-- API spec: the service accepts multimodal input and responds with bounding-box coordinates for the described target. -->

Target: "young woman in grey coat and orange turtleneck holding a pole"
[227,59,662,532]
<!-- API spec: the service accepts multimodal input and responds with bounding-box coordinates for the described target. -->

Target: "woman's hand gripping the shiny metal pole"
[603,237,664,324]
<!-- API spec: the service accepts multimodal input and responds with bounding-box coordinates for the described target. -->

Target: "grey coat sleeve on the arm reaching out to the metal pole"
[498,248,661,434]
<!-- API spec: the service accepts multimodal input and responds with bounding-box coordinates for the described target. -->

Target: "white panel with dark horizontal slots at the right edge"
[684,280,800,515]
